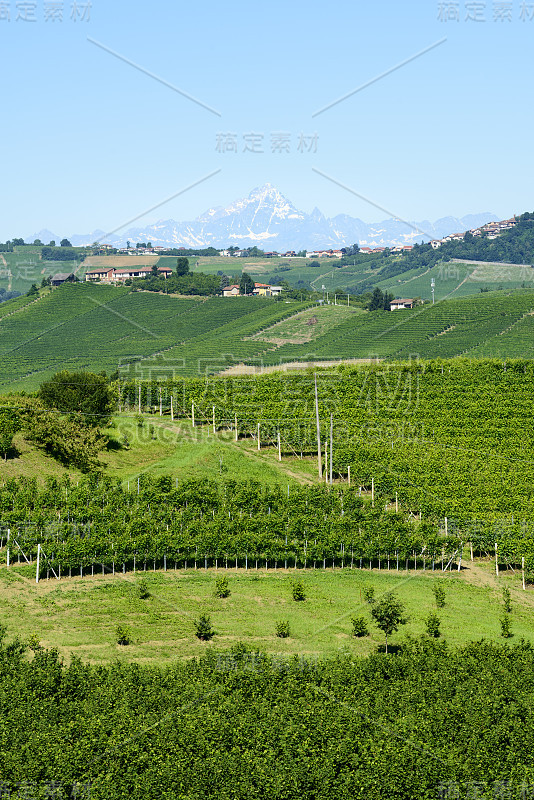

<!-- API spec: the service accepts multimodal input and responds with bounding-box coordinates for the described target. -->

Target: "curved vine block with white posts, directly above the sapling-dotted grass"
[0,476,461,575]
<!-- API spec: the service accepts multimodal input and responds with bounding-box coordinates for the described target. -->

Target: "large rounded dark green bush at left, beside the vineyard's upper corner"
[38,370,115,427]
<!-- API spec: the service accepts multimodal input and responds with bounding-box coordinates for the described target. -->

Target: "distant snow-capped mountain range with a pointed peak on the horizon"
[26,183,498,252]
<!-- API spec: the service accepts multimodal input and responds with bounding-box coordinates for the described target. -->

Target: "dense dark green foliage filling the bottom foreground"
[0,636,534,800]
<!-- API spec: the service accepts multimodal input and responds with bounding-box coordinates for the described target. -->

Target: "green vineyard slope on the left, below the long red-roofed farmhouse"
[0,284,314,390]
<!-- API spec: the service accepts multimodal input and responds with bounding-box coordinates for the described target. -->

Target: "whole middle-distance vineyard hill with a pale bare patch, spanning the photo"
[0,284,534,392]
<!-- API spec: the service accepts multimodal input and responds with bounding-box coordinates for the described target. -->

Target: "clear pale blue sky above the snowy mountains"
[0,0,534,241]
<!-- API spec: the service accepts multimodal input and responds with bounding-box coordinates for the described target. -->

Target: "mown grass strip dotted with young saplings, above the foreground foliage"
[0,561,534,662]
